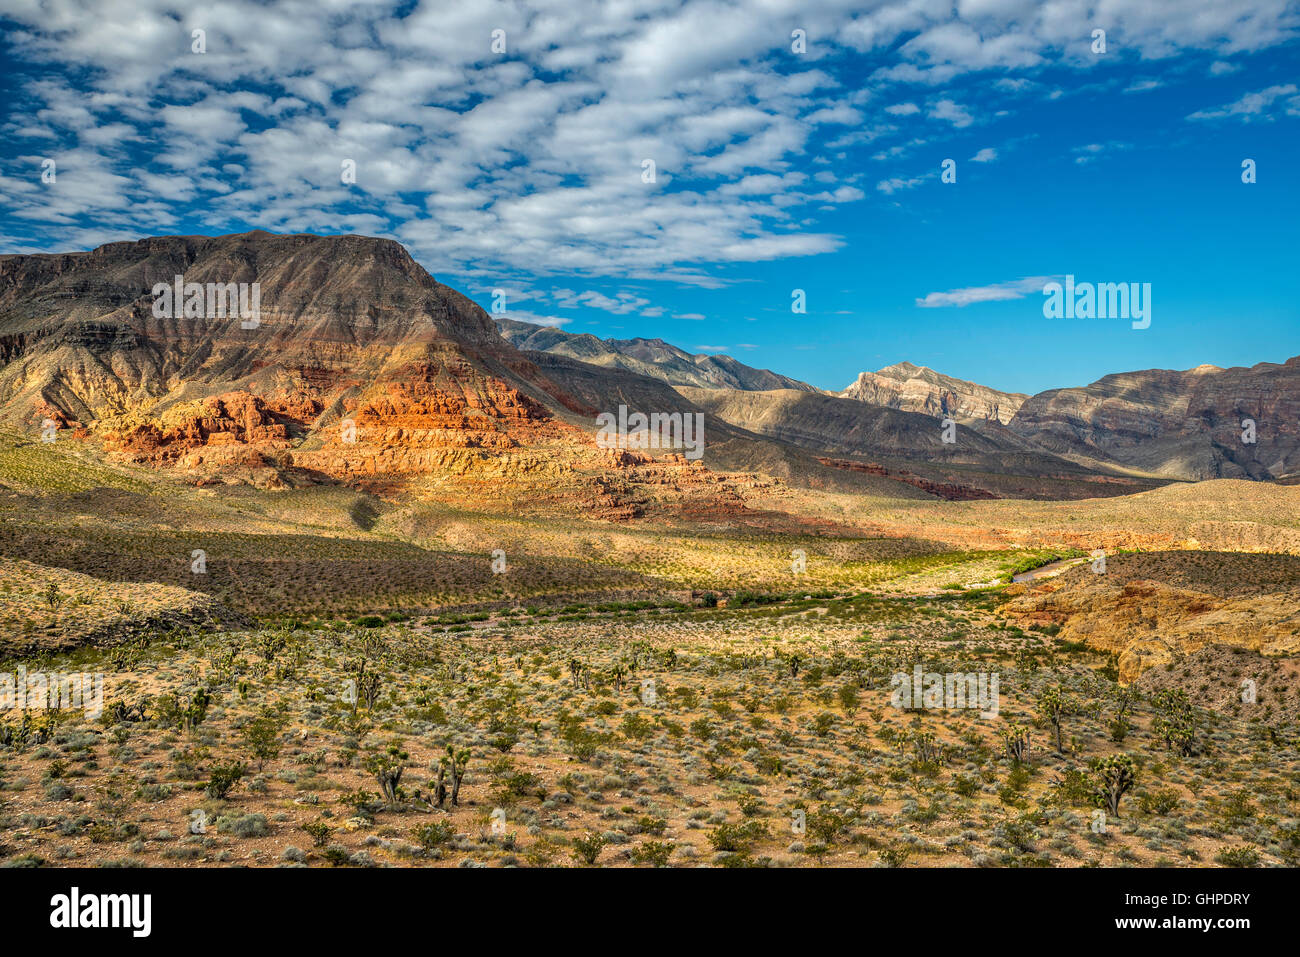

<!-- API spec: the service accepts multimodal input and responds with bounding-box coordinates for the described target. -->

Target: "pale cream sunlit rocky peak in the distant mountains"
[840,363,1028,425]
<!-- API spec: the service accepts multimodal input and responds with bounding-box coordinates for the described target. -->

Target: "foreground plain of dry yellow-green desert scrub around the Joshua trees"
[0,579,1300,866]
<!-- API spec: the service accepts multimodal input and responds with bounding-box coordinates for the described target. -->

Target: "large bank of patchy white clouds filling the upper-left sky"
[0,0,1300,299]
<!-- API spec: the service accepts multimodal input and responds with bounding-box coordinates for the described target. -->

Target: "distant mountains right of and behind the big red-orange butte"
[498,320,1300,481]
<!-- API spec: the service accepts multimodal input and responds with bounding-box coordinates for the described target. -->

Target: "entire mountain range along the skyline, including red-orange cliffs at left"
[0,231,1300,518]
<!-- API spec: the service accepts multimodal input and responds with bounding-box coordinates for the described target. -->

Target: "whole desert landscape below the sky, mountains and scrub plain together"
[0,230,1300,867]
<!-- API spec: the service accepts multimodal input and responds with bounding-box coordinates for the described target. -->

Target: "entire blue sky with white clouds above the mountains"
[0,0,1300,393]
